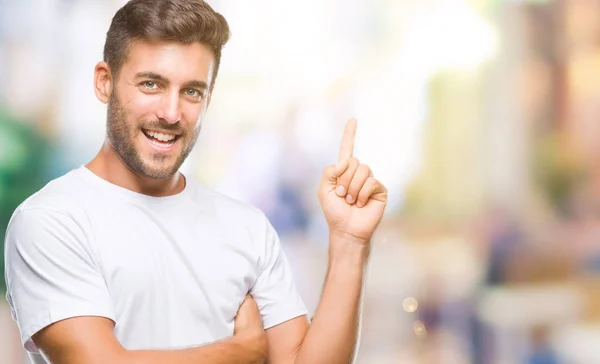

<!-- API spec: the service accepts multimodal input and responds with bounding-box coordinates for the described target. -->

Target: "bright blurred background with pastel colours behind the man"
[0,0,600,364]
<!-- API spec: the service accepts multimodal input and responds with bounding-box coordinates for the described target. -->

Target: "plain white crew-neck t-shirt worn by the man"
[5,166,307,363]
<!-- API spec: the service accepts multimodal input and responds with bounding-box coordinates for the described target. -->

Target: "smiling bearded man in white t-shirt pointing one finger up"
[6,0,387,364]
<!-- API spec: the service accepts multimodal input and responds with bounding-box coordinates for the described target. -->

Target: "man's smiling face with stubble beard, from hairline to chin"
[107,42,214,179]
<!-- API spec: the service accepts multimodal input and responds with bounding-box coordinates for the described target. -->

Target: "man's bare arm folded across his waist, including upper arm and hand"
[33,300,267,364]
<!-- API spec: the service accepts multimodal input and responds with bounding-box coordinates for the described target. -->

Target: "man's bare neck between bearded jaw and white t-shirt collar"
[86,141,185,197]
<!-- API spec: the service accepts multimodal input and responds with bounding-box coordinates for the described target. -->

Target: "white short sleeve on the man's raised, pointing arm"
[250,213,308,329]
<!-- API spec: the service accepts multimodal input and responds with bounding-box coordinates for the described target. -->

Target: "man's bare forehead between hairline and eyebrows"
[120,41,215,84]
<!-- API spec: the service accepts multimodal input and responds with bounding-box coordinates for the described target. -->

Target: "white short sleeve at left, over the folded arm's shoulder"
[5,209,114,353]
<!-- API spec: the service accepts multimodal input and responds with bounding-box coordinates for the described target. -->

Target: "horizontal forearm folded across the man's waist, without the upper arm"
[121,336,266,364]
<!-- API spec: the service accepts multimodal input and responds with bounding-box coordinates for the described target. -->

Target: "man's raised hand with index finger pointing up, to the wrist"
[319,119,387,244]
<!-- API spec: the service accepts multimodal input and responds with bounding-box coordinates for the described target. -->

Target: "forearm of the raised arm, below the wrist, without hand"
[295,235,369,364]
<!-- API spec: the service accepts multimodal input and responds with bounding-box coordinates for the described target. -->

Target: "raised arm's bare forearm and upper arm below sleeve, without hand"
[267,236,368,364]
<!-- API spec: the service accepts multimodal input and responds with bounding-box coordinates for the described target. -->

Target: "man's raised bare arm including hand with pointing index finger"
[267,119,387,364]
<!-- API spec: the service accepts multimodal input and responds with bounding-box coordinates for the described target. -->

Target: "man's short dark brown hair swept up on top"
[104,0,229,85]
